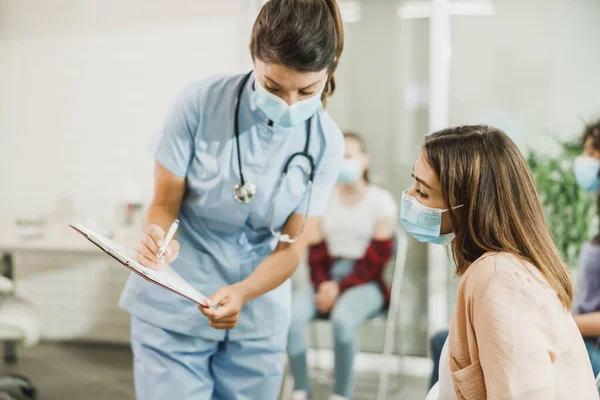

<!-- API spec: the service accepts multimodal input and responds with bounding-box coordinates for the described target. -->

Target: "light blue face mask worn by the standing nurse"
[254,80,325,128]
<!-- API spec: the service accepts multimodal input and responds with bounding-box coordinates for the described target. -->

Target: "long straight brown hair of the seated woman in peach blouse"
[423,125,573,310]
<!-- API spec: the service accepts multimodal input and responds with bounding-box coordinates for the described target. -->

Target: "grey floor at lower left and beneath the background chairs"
[1,343,427,400]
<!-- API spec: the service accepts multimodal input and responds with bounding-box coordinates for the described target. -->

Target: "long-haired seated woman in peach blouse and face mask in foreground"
[412,125,598,400]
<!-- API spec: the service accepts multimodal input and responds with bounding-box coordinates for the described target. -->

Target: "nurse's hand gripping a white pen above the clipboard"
[137,219,179,269]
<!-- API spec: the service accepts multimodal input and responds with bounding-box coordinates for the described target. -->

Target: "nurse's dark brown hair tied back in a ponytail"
[250,0,344,104]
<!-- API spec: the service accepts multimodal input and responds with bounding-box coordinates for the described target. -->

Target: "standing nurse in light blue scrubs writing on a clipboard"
[121,0,344,400]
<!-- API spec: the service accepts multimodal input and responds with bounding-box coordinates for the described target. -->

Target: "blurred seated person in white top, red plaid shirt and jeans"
[288,133,397,399]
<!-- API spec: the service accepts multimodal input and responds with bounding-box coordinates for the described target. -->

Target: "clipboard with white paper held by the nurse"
[69,222,206,307]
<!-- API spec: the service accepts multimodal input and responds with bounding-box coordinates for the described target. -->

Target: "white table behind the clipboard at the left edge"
[0,221,142,363]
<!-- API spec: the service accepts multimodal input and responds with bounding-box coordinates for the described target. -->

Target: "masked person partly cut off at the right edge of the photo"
[573,120,600,375]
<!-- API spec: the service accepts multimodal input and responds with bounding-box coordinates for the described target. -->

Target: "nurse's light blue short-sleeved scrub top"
[120,75,344,340]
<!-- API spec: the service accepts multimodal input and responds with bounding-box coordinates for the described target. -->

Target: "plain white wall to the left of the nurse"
[0,0,250,219]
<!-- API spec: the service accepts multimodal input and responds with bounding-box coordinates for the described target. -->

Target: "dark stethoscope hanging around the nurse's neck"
[233,71,315,243]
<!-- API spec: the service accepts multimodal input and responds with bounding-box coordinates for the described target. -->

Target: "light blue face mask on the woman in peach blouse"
[400,190,462,246]
